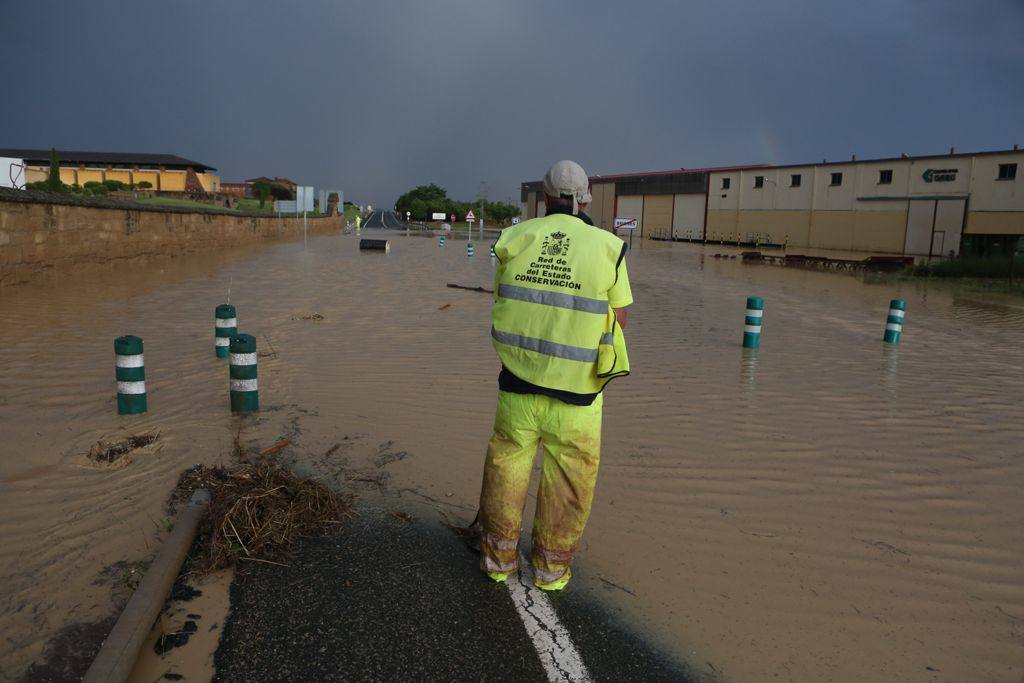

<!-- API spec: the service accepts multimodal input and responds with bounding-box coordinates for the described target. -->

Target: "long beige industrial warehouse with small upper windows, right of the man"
[521,145,1024,256]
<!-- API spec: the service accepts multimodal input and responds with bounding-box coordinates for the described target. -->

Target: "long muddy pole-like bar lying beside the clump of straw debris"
[82,489,210,683]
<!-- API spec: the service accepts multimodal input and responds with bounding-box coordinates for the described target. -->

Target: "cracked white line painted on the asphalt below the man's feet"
[507,557,593,683]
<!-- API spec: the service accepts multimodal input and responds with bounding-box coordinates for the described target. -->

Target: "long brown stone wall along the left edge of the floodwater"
[0,188,344,286]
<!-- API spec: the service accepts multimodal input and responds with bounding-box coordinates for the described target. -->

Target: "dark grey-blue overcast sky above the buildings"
[0,0,1024,205]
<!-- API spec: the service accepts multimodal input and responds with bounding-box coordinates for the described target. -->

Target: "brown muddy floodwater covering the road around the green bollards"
[0,236,1024,683]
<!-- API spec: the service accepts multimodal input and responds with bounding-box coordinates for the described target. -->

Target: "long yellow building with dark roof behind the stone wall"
[0,148,220,193]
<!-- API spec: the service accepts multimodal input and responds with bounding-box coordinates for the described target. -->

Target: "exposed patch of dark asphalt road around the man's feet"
[215,509,694,681]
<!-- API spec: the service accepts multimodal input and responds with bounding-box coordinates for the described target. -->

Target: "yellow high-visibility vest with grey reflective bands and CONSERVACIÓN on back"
[490,214,629,394]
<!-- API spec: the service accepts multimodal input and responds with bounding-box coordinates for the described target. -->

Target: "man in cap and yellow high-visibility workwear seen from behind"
[476,161,633,591]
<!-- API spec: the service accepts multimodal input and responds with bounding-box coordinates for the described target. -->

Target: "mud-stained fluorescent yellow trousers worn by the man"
[479,391,603,584]
